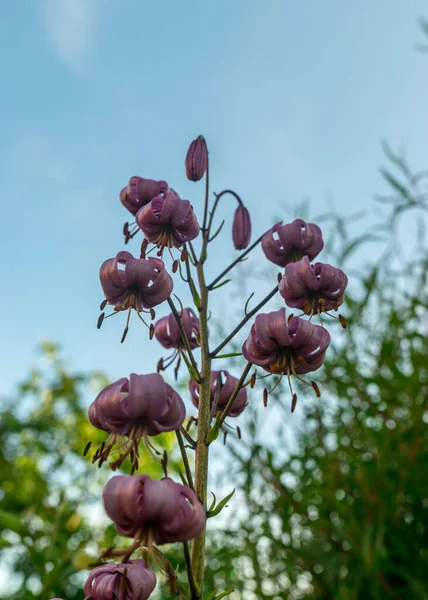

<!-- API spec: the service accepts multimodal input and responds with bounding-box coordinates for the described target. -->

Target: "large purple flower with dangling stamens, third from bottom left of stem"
[88,373,186,469]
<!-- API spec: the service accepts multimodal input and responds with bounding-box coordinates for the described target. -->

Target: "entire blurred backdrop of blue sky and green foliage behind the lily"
[0,0,428,600]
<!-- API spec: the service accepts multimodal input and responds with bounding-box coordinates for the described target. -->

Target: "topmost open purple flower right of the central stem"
[262,219,324,267]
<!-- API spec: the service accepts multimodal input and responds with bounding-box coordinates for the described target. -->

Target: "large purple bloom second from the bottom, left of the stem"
[103,475,206,547]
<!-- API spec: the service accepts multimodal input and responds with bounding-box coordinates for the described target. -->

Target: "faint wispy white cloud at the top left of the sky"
[42,0,96,72]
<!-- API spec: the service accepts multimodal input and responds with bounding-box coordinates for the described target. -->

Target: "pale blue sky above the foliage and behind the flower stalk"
[0,0,428,392]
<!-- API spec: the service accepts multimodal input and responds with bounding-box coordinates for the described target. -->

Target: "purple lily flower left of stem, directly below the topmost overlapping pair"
[100,251,173,311]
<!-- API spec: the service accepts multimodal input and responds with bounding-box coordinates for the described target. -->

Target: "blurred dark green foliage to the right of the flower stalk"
[206,151,428,600]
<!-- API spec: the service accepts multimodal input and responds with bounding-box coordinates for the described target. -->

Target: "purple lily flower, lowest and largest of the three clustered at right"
[242,308,330,375]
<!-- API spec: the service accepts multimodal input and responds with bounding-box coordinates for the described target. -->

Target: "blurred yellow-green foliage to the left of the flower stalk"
[0,342,177,600]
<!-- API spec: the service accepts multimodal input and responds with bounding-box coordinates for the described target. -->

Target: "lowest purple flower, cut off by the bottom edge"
[84,558,156,600]
